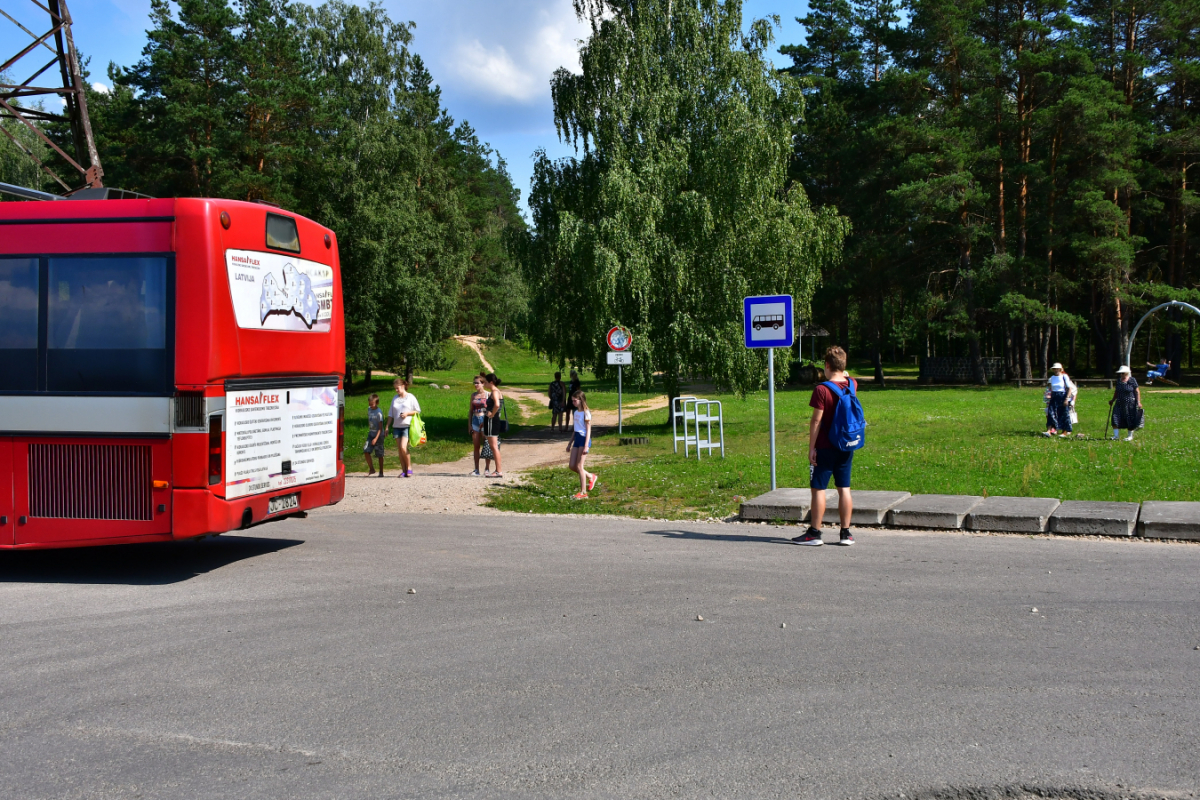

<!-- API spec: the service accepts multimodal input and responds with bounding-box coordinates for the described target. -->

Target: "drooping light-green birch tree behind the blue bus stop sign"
[524,0,846,395]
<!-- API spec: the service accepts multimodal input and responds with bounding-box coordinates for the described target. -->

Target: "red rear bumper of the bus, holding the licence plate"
[172,467,346,539]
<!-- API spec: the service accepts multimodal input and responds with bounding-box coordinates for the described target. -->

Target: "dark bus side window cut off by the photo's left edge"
[0,258,38,391]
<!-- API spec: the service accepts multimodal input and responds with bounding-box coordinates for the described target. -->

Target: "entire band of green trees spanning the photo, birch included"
[0,0,1200,389]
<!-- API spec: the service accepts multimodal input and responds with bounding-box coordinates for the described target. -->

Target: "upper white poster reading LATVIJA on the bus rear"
[226,249,334,332]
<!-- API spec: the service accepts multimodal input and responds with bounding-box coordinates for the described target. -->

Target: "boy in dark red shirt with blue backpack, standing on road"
[792,345,865,547]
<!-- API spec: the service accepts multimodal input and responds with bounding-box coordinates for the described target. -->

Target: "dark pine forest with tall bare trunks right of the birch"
[781,0,1200,383]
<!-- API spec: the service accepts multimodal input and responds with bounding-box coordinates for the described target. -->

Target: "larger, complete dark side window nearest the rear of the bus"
[46,255,173,393]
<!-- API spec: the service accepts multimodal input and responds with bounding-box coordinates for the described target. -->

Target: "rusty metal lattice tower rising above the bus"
[0,0,104,194]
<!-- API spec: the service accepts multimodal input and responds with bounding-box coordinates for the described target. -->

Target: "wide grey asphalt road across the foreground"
[0,513,1200,800]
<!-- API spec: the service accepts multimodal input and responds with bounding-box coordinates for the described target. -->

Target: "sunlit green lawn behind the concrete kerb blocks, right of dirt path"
[492,385,1200,519]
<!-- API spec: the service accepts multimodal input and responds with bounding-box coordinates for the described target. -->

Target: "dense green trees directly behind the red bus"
[0,0,526,381]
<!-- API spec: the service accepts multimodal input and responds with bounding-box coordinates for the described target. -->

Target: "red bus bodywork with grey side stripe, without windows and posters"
[0,199,346,549]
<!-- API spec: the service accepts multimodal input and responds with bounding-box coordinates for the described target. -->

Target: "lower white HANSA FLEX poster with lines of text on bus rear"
[224,386,337,499]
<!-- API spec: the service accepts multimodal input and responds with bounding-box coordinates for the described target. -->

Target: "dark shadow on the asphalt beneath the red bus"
[0,536,304,587]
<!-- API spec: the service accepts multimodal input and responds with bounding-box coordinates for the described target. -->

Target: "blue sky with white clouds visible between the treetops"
[0,0,806,215]
